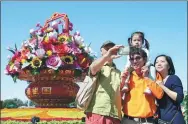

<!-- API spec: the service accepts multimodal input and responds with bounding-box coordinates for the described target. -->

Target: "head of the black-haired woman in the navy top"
[154,54,175,75]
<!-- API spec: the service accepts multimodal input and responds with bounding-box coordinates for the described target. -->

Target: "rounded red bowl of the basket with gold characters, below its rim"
[25,81,79,108]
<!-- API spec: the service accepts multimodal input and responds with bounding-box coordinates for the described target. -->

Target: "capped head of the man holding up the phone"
[100,40,115,56]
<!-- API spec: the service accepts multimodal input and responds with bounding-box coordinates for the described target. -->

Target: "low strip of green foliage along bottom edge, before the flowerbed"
[1,120,85,124]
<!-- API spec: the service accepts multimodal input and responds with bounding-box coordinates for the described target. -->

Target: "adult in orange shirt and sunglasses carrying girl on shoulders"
[121,48,163,124]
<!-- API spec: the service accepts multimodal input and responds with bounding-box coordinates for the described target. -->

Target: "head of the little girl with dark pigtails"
[128,31,149,50]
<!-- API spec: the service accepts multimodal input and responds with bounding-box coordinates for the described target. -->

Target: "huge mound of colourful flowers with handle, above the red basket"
[5,13,95,82]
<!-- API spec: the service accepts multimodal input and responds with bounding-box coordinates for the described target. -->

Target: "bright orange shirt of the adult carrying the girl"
[123,71,163,118]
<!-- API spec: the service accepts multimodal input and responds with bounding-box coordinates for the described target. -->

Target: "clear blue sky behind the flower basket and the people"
[1,1,187,100]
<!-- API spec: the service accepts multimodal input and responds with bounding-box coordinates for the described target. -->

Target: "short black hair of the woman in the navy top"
[154,54,175,75]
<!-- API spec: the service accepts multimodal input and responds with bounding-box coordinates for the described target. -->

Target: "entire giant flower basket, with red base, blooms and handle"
[5,13,95,107]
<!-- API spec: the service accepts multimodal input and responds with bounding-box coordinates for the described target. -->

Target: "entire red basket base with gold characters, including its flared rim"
[19,70,79,108]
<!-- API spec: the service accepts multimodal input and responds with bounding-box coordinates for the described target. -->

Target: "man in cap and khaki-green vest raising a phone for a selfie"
[85,41,122,124]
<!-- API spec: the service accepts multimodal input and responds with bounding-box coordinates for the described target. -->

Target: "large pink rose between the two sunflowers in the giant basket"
[46,55,62,70]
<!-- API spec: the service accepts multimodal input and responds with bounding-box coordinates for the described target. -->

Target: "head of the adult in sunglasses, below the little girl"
[129,47,147,71]
